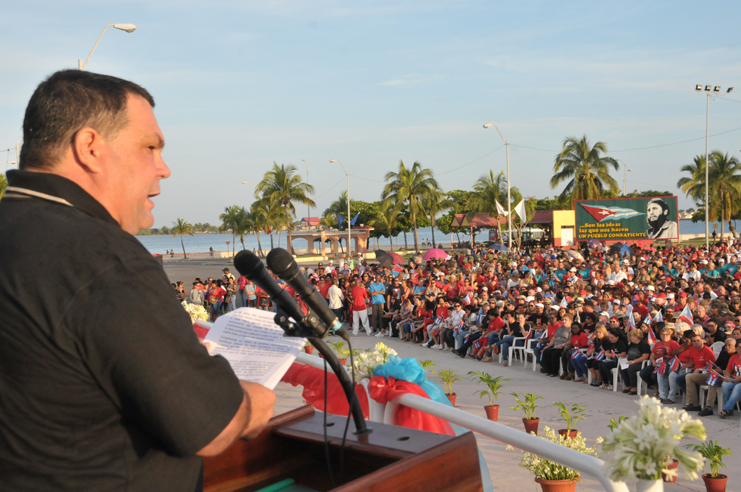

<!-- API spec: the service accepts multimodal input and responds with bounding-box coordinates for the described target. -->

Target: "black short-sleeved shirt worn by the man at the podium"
[0,171,243,491]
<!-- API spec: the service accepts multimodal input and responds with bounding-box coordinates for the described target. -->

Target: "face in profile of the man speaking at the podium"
[100,95,170,234]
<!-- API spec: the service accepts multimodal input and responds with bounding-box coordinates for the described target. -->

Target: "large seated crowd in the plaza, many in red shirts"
[175,241,741,418]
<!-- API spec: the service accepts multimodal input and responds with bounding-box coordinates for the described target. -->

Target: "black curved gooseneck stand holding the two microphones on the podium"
[275,307,373,435]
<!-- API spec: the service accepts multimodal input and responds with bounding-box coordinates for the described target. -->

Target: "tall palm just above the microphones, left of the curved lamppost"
[255,162,316,253]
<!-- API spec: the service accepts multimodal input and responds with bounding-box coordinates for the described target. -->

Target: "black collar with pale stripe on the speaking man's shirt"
[8,170,117,224]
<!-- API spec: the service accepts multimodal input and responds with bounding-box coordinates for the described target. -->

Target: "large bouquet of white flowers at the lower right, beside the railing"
[602,396,706,482]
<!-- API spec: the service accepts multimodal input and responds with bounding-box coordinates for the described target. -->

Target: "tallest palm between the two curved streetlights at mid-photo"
[381,161,440,251]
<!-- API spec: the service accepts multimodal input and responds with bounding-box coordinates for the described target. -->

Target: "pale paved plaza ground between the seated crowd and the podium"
[165,260,741,492]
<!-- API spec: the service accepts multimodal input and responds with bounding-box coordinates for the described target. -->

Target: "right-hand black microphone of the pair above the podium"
[266,248,349,341]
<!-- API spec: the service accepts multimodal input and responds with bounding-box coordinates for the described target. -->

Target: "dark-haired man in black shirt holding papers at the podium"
[0,70,275,491]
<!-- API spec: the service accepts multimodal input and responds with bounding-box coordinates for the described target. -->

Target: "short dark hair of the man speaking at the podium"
[18,70,154,169]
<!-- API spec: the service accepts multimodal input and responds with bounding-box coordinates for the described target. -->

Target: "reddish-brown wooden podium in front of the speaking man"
[204,406,482,492]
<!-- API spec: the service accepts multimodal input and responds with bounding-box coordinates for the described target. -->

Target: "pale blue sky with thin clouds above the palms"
[0,0,741,227]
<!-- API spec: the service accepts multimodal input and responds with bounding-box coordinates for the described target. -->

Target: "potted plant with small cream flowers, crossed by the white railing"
[507,426,602,492]
